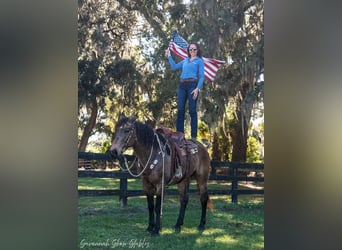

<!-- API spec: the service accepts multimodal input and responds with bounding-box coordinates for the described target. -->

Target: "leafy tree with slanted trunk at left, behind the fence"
[78,0,136,151]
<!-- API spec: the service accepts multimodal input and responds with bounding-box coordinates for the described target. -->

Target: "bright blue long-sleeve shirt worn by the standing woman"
[168,55,204,89]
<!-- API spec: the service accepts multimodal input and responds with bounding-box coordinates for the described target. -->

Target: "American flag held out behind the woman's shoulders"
[169,31,225,82]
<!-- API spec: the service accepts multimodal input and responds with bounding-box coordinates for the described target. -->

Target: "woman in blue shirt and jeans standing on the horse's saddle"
[165,43,204,140]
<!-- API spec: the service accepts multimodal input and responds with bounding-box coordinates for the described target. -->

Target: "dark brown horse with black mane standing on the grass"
[108,114,213,236]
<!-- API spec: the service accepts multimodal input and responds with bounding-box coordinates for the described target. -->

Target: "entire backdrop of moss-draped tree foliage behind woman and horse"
[78,0,264,161]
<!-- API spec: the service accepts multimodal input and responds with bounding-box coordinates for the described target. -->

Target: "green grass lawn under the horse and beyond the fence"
[78,178,264,250]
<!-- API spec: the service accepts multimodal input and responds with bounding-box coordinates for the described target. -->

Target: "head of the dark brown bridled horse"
[109,114,137,159]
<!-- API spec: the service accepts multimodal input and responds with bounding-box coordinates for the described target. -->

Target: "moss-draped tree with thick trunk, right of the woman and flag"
[187,0,264,161]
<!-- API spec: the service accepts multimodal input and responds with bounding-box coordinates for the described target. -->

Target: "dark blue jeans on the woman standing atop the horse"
[176,81,198,138]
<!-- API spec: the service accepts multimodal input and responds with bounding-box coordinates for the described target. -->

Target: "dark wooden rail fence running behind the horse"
[78,152,264,206]
